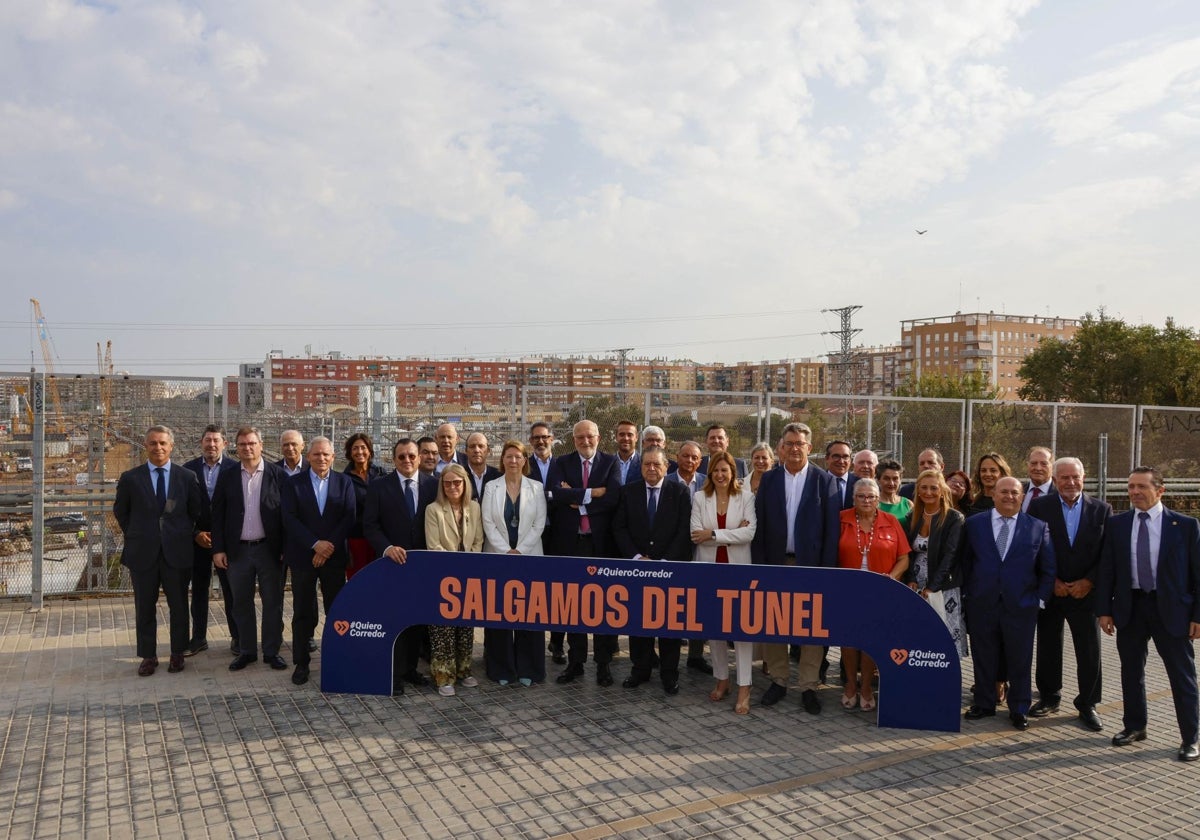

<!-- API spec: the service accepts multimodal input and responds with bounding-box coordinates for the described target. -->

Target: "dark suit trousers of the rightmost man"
[1117,592,1200,744]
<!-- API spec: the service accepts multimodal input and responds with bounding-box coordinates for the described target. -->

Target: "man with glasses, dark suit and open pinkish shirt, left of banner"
[212,426,288,671]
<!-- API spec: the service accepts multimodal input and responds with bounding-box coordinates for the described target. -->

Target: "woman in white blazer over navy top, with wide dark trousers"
[482,440,546,686]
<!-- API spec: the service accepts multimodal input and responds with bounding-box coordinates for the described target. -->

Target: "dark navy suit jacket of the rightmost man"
[1096,508,1200,637]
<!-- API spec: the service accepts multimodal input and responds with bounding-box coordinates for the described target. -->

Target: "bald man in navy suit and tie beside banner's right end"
[962,476,1055,730]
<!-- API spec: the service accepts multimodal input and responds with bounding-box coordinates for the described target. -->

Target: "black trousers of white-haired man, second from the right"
[1034,593,1100,710]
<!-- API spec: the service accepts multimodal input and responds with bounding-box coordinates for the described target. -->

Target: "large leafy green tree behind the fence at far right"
[1018,311,1200,406]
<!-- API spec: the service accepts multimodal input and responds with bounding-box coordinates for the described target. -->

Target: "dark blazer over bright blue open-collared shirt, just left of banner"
[282,469,355,569]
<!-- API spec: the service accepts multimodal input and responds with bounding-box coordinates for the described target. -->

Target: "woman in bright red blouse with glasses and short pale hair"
[838,479,908,712]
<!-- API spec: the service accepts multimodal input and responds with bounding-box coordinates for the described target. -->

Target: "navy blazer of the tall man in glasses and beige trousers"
[750,462,841,568]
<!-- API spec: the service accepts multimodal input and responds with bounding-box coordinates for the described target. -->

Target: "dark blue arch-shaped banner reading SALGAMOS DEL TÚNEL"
[320,551,962,732]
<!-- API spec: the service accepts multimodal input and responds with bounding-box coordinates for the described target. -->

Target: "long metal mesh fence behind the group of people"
[7,372,1200,598]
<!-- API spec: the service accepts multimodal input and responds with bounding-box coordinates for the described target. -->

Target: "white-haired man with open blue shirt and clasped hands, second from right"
[1028,458,1112,732]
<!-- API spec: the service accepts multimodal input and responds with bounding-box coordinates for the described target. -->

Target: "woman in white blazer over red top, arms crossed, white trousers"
[691,452,757,714]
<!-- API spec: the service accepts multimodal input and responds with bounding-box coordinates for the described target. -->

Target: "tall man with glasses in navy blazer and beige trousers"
[750,422,841,714]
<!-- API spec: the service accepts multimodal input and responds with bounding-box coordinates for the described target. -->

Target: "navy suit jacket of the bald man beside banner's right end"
[961,511,1055,618]
